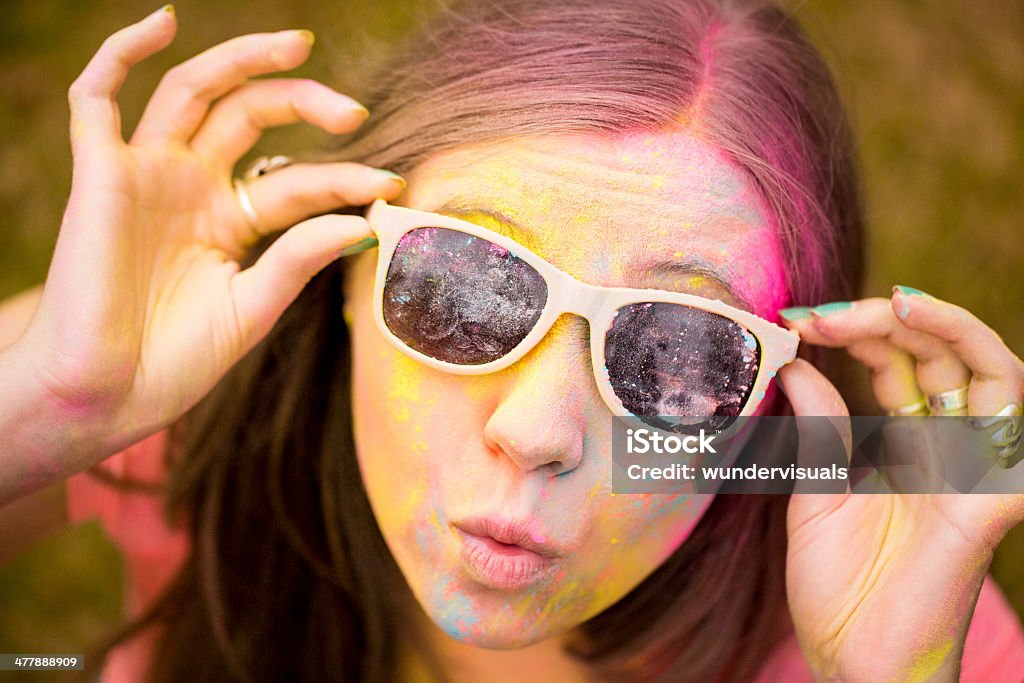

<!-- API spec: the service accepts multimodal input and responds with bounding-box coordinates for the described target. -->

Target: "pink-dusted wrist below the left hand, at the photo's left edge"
[0,341,113,506]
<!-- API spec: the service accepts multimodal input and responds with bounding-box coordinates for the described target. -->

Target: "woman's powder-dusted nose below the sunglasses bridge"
[483,314,603,475]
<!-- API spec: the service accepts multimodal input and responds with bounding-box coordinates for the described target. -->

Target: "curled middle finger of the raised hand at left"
[191,79,370,166]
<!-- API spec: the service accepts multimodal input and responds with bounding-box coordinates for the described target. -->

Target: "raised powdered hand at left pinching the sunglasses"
[15,6,403,453]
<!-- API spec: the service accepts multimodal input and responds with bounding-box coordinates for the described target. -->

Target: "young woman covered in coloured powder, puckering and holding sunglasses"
[0,0,1024,681]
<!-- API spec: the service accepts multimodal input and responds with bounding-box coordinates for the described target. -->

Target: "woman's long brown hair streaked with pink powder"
[81,0,862,683]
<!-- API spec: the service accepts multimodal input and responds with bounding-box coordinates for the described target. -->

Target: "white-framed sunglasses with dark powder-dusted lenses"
[366,200,800,429]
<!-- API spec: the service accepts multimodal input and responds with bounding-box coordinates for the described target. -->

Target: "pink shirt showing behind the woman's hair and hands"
[68,432,1024,683]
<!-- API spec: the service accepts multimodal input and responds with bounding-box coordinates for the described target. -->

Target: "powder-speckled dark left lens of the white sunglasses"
[384,227,548,366]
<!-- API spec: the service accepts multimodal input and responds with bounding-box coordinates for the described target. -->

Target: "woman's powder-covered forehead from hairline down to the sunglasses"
[402,131,784,315]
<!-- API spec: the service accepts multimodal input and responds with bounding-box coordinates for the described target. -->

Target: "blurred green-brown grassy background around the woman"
[0,0,1024,680]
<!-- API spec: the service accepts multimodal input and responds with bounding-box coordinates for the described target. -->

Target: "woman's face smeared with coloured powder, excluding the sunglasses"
[346,126,785,648]
